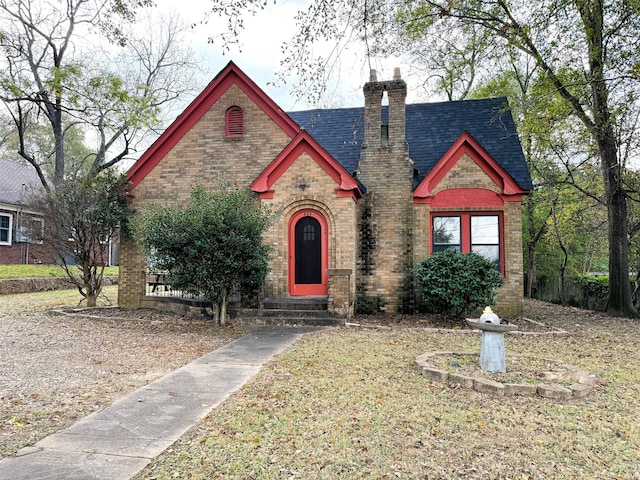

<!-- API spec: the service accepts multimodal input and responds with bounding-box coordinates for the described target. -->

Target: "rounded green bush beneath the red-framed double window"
[414,250,503,317]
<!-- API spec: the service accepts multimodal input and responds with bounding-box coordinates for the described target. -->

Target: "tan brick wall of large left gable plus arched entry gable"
[119,86,356,308]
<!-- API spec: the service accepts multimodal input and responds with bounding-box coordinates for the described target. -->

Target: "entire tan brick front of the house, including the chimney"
[119,62,523,316]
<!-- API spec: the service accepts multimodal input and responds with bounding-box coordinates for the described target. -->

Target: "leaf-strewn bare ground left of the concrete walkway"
[0,309,244,457]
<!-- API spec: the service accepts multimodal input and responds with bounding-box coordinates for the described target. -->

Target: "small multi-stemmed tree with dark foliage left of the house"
[31,171,129,307]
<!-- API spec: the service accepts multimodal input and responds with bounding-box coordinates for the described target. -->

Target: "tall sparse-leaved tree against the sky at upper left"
[0,0,197,190]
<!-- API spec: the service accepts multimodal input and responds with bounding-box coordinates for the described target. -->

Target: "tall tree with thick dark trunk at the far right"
[401,0,640,316]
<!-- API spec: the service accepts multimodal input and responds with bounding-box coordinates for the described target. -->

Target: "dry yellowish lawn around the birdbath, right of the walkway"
[136,320,640,480]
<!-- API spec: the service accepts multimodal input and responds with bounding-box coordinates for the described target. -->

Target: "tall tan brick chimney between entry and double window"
[357,68,413,312]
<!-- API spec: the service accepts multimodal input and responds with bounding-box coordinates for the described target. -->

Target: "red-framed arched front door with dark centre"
[289,209,328,295]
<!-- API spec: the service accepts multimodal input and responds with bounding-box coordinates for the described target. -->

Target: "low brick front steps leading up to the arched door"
[229,296,345,326]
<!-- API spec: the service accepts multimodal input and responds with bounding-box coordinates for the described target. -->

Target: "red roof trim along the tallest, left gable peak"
[128,62,300,189]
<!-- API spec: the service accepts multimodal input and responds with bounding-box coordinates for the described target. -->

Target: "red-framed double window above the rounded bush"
[431,213,502,271]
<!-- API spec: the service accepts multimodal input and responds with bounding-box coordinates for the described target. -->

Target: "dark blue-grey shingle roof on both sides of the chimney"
[289,97,533,190]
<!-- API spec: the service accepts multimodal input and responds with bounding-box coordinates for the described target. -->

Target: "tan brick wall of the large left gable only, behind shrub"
[119,85,290,308]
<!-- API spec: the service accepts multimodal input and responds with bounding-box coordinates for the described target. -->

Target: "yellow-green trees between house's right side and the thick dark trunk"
[470,60,606,297]
